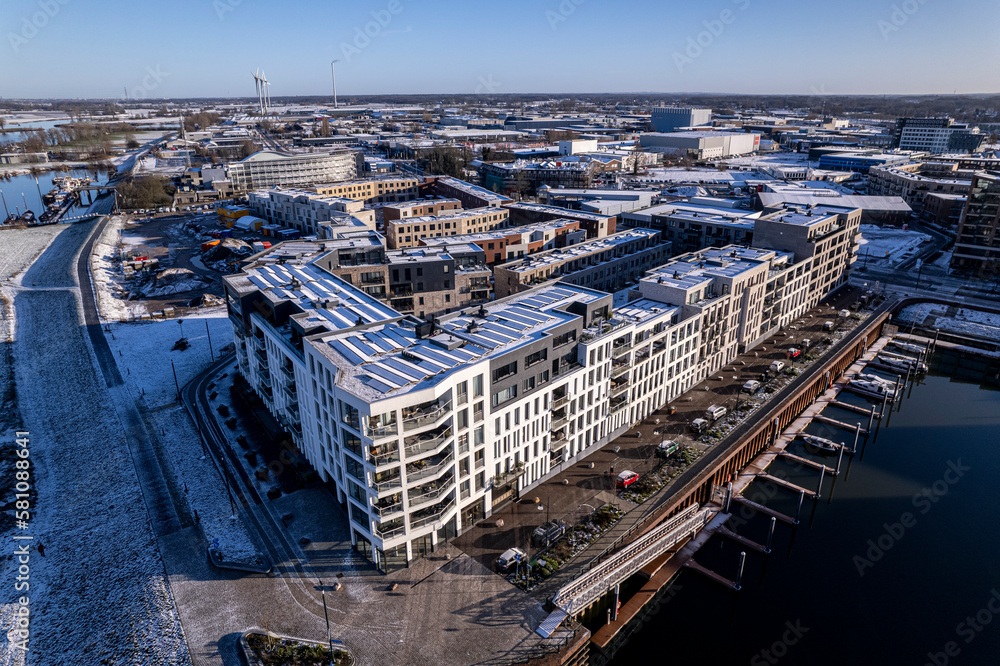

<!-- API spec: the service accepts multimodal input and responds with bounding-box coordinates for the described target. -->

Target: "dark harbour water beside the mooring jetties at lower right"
[613,344,1000,666]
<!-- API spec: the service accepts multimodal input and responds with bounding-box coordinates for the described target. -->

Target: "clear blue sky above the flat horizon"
[0,0,1000,97]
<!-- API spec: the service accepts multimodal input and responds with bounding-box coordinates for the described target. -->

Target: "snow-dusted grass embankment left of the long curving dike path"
[0,224,189,666]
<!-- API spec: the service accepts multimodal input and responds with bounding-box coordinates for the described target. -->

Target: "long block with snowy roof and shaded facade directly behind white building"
[493,229,671,298]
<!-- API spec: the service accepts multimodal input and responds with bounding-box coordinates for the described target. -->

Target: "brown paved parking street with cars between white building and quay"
[454,289,861,566]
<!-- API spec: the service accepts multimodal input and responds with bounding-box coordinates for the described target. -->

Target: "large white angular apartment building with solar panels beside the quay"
[223,227,856,571]
